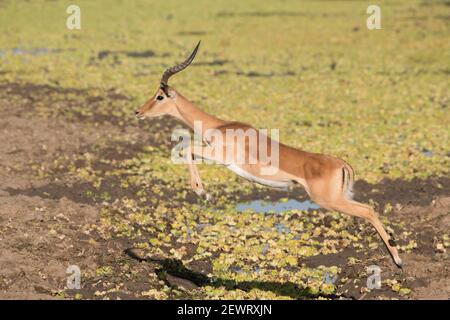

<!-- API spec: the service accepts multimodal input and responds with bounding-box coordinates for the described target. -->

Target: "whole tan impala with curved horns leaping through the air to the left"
[136,42,402,267]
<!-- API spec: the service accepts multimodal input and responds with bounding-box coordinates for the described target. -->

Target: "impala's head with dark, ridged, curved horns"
[136,41,200,119]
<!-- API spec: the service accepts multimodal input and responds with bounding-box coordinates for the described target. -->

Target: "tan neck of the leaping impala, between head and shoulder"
[172,92,225,134]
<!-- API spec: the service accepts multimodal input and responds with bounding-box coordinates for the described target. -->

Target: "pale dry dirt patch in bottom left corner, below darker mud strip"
[0,192,97,299]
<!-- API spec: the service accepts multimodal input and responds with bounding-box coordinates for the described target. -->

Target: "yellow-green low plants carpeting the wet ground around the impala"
[0,0,450,298]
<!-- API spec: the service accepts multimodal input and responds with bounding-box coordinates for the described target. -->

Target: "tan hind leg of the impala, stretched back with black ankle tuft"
[326,197,402,268]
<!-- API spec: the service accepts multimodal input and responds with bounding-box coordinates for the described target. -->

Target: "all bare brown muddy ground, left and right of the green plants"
[0,83,450,299]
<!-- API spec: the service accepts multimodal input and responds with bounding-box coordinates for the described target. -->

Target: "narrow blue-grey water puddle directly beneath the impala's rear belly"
[236,199,320,213]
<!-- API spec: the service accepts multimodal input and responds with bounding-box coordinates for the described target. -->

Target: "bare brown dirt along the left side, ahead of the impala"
[0,84,181,299]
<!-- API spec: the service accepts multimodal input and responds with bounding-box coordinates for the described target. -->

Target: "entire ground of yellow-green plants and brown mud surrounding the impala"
[0,1,450,299]
